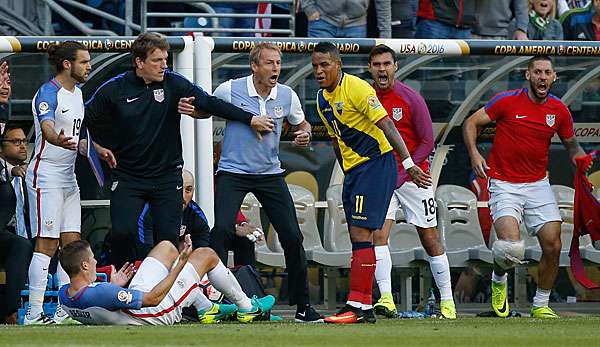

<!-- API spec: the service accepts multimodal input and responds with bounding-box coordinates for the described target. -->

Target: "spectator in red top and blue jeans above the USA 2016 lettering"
[415,0,475,39]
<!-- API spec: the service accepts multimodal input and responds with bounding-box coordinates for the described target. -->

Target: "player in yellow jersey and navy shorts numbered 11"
[312,42,431,323]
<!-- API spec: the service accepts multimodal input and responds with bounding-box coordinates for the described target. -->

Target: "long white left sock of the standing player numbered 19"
[29,252,50,318]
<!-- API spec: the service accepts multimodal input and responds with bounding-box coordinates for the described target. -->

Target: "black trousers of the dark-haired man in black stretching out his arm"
[110,172,183,269]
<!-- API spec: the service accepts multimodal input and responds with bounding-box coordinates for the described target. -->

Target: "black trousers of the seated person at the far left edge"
[0,229,33,321]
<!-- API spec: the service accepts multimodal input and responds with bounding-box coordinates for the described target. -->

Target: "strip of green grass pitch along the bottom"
[0,316,600,347]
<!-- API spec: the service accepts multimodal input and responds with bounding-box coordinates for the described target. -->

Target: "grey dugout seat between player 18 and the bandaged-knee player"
[436,185,493,267]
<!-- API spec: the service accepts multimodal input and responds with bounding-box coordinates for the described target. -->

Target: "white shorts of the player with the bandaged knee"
[489,178,562,236]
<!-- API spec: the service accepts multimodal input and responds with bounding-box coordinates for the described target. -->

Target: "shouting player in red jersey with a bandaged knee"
[463,56,585,318]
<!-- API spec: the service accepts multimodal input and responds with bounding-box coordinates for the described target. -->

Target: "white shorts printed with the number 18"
[385,182,437,228]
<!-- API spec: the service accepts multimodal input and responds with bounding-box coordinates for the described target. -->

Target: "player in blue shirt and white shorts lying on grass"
[58,235,275,325]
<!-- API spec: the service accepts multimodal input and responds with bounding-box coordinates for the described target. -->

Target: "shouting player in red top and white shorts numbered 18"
[369,45,456,319]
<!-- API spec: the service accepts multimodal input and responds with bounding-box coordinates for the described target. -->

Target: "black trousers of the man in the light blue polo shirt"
[211,172,309,305]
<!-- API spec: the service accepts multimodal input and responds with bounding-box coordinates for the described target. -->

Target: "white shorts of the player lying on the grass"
[127,257,203,325]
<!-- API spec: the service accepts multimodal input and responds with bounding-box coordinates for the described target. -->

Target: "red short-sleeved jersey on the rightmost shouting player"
[485,88,575,183]
